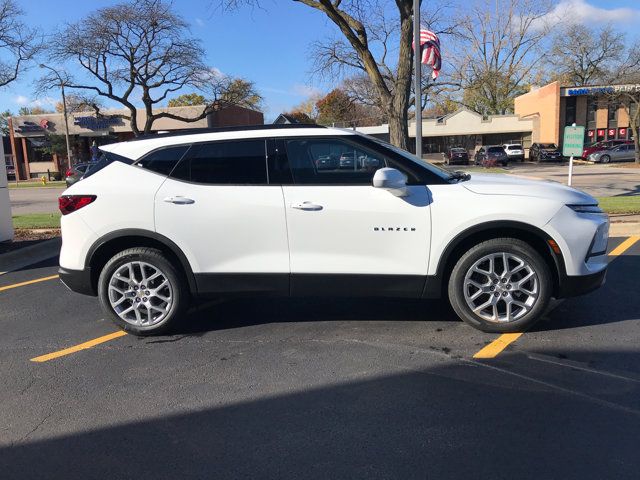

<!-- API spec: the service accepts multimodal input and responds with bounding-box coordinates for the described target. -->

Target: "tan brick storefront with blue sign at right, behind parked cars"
[514,82,640,145]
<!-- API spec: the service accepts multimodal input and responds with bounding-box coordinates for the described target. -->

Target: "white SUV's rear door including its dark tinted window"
[155,139,289,294]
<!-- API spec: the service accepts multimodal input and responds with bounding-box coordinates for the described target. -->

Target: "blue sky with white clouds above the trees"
[0,0,640,120]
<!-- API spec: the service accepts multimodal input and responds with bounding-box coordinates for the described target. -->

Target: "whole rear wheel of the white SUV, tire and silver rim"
[98,247,189,335]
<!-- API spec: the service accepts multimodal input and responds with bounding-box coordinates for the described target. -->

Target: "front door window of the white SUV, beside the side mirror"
[286,138,387,185]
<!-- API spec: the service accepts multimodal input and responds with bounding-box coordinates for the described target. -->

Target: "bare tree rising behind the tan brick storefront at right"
[545,24,625,86]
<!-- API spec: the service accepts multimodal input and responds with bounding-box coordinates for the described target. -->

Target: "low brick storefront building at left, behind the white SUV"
[5,106,264,180]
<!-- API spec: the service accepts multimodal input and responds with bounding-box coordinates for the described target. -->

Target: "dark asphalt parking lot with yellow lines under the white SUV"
[0,237,640,479]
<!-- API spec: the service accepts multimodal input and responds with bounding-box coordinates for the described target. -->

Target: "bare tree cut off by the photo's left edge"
[0,0,41,87]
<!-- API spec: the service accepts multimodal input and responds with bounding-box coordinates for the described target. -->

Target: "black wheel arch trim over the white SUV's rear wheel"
[85,228,197,295]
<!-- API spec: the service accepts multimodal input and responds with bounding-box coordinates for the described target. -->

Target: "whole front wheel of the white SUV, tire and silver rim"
[448,238,552,333]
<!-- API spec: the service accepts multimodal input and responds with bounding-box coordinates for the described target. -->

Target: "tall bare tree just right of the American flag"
[450,0,551,115]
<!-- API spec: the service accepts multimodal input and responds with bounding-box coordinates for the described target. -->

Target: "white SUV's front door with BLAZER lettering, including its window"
[281,137,431,296]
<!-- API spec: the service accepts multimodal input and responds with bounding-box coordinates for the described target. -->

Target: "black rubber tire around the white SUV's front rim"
[448,238,553,333]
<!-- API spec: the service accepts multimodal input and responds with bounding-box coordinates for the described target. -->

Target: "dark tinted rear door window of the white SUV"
[171,139,267,185]
